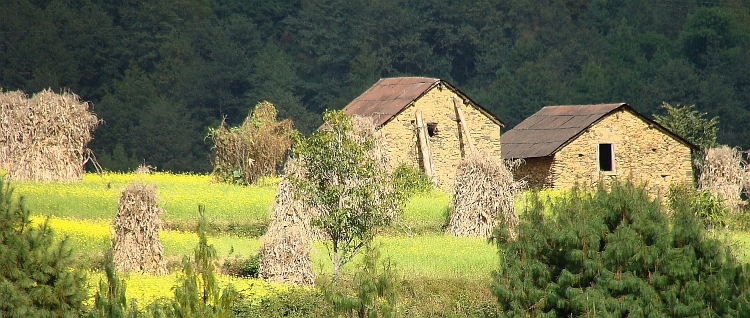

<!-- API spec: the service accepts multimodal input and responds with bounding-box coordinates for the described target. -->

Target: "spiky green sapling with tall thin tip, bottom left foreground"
[164,205,236,317]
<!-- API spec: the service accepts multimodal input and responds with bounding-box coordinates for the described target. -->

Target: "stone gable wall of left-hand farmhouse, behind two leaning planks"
[380,87,501,190]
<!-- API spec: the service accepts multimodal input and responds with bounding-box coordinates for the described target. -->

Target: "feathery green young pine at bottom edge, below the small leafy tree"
[322,246,398,318]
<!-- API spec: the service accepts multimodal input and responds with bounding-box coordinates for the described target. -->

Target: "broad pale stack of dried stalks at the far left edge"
[0,90,99,181]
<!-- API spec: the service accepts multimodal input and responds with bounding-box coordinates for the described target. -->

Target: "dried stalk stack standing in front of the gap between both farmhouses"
[447,154,524,237]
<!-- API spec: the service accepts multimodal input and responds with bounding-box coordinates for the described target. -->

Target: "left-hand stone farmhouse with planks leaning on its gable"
[343,77,505,189]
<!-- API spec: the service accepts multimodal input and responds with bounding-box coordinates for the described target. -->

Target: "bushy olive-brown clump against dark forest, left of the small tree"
[209,101,292,184]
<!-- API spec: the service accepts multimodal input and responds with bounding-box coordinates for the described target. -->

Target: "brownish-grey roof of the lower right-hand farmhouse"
[500,103,696,159]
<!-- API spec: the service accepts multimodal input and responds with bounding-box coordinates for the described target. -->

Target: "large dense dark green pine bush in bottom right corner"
[491,182,750,317]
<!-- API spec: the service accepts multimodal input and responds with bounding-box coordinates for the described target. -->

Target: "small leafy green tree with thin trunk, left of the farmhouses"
[291,111,399,281]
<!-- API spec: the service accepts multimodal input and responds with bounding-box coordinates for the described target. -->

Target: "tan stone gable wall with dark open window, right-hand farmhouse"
[551,110,693,195]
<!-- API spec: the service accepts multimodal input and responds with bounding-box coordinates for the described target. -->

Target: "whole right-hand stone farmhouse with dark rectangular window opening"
[502,103,697,195]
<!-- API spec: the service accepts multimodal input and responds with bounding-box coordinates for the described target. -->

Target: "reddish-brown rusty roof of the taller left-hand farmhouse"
[343,77,505,127]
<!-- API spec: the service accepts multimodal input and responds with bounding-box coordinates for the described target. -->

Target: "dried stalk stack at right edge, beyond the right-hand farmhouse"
[698,145,747,207]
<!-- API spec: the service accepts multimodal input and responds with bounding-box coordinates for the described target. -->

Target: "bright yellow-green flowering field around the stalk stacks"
[12,173,750,316]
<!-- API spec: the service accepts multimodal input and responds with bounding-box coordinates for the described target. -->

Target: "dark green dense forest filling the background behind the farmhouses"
[0,0,750,172]
